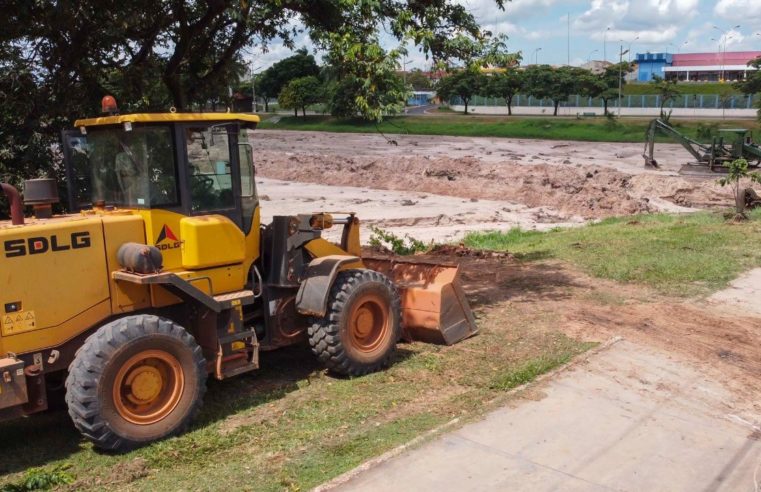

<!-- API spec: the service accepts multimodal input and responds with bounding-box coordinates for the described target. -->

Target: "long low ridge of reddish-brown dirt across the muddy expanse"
[258,151,654,218]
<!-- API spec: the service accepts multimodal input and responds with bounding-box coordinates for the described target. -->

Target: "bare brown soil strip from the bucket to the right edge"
[430,257,761,414]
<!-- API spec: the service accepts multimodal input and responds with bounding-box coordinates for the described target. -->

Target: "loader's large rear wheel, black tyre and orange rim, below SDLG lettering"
[66,315,207,450]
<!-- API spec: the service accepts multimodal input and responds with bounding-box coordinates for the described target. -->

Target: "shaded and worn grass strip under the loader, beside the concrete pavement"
[0,312,593,491]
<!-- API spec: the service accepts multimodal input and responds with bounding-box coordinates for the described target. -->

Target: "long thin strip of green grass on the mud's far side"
[260,113,756,142]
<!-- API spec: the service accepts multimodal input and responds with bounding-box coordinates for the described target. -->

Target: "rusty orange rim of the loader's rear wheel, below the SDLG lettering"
[113,350,185,425]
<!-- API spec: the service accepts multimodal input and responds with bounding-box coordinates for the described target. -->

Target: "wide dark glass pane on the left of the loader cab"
[67,126,178,208]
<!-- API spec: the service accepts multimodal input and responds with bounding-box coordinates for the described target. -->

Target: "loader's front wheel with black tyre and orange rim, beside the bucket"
[309,270,401,376]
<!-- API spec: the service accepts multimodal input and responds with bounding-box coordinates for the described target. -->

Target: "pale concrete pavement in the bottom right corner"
[326,341,761,492]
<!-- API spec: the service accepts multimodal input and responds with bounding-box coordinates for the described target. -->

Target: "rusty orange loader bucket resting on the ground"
[362,258,478,345]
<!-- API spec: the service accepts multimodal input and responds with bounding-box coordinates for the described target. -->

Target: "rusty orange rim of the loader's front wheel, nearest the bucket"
[348,294,391,353]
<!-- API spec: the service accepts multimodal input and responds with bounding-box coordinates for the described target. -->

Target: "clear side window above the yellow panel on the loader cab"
[185,126,235,212]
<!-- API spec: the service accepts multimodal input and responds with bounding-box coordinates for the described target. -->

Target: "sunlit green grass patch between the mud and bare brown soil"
[465,211,761,296]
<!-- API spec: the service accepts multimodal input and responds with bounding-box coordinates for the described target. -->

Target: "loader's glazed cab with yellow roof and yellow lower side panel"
[63,113,259,269]
